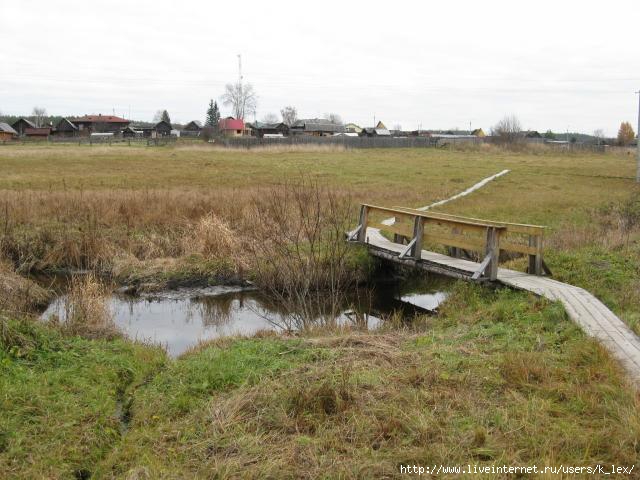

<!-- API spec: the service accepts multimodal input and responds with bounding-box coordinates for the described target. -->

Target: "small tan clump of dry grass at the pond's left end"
[61,274,120,338]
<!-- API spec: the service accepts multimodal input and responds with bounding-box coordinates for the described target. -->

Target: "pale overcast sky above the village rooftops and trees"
[0,0,640,135]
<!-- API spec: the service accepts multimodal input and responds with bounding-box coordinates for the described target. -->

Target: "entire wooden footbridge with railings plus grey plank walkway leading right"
[348,205,640,387]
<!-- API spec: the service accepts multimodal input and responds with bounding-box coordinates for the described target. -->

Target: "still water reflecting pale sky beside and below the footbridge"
[41,277,449,357]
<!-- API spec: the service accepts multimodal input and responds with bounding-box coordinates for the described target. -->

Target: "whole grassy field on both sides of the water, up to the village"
[0,145,640,479]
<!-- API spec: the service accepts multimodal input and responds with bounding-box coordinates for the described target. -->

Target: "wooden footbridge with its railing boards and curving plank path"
[349,205,640,389]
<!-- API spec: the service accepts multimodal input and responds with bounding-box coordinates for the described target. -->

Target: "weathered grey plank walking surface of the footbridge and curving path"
[366,227,640,389]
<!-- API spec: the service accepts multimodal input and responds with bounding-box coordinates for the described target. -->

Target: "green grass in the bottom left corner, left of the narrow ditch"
[0,319,166,478]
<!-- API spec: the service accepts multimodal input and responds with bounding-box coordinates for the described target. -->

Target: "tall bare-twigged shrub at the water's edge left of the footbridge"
[245,177,354,330]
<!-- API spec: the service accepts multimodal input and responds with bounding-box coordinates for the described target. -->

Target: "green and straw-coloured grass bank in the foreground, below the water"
[0,283,640,478]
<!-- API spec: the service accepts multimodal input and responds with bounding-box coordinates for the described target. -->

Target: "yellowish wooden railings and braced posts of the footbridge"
[350,204,550,280]
